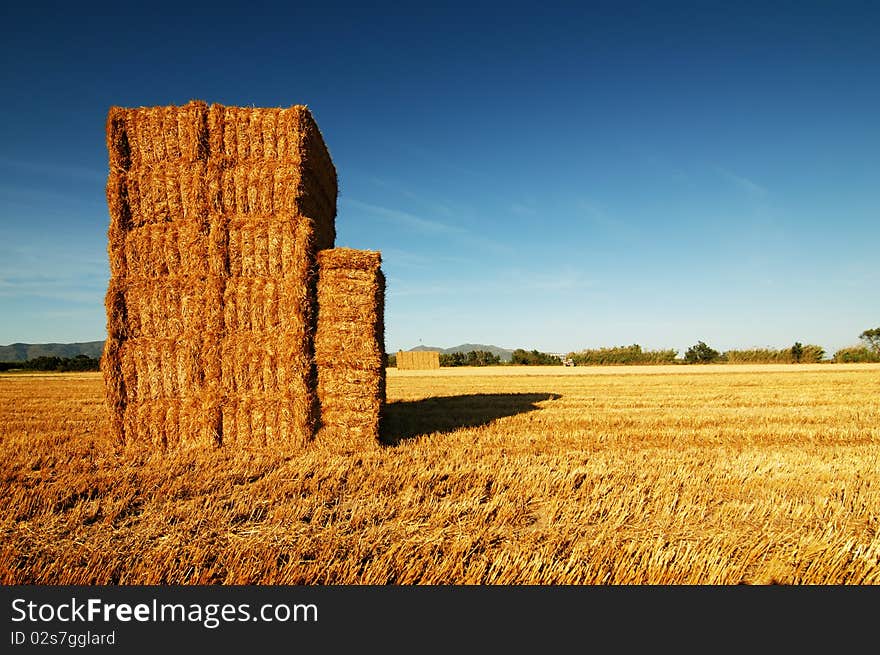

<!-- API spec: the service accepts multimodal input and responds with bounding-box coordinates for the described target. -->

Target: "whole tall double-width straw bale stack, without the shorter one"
[102,101,337,448]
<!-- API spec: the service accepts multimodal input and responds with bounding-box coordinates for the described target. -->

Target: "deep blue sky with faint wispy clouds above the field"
[0,2,880,353]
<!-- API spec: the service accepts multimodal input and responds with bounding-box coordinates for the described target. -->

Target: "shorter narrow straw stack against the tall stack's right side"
[315,248,385,449]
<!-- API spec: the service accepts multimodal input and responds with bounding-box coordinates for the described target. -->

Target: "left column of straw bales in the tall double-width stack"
[101,101,223,449]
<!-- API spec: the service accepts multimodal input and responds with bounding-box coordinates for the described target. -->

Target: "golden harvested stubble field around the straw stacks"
[0,364,880,585]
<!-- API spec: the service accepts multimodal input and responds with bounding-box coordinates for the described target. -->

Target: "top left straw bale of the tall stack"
[107,100,208,171]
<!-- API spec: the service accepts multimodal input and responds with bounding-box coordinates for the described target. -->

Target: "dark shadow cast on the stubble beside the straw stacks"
[381,393,562,446]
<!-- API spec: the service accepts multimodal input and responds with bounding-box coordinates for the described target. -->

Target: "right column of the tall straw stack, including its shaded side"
[208,105,337,450]
